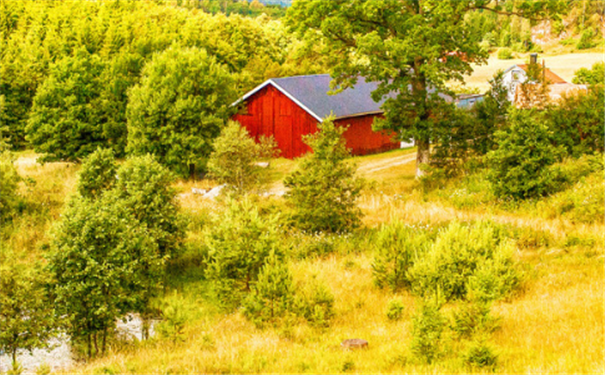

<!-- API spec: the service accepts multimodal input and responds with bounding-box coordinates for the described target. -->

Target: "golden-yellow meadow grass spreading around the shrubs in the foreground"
[8,148,605,374]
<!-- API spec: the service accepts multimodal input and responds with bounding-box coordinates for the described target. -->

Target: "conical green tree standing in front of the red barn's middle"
[284,118,362,232]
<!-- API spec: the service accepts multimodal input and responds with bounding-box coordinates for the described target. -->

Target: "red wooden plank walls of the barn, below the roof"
[233,85,399,159]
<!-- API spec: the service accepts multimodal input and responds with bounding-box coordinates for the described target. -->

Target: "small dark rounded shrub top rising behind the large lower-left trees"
[78,148,117,198]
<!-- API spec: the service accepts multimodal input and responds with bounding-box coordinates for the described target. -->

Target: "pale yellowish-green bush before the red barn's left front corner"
[208,121,274,193]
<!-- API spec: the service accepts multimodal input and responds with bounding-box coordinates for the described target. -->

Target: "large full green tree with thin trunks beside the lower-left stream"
[49,194,160,358]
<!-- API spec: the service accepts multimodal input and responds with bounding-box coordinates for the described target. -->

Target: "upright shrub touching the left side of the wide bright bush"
[372,221,431,291]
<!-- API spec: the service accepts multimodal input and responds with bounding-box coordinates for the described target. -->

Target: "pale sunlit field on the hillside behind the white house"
[466,52,605,92]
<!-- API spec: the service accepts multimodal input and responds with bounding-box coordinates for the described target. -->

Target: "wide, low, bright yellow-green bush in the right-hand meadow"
[408,222,518,301]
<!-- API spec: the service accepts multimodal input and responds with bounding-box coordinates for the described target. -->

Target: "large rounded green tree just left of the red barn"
[127,46,235,177]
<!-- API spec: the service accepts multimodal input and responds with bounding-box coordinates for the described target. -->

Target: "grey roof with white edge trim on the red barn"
[236,74,449,121]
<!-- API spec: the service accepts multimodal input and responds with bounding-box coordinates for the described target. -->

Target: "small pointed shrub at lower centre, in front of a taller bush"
[244,252,294,326]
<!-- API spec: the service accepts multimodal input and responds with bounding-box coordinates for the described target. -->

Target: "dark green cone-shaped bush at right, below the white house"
[487,110,563,199]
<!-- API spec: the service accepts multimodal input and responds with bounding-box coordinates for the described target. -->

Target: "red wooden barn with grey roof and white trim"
[233,74,399,159]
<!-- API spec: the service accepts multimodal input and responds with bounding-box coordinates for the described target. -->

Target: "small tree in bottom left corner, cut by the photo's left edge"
[0,258,55,366]
